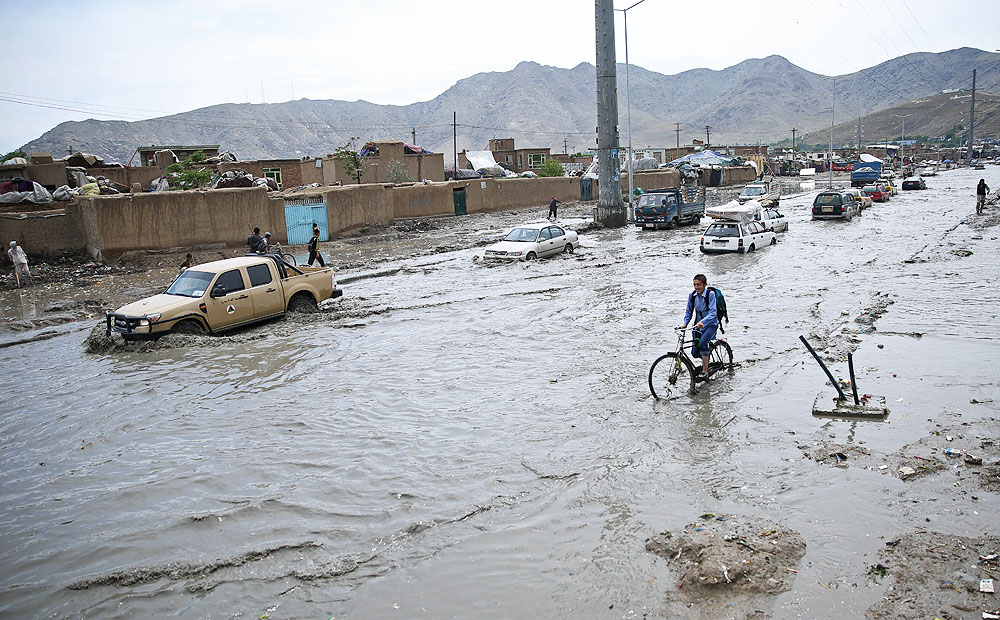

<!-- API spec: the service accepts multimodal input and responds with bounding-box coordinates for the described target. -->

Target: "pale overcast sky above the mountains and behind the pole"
[0,0,1000,156]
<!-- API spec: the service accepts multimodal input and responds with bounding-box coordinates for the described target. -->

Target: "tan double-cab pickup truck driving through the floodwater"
[106,254,341,340]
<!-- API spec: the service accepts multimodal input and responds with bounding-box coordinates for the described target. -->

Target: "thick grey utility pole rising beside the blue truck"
[594,0,626,227]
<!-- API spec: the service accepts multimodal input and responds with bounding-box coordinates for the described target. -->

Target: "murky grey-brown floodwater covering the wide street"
[0,167,1000,619]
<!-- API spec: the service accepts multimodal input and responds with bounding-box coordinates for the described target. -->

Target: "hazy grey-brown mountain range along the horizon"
[22,48,1000,163]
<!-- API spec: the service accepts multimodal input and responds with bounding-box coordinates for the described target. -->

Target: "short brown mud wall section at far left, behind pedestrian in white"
[0,209,87,258]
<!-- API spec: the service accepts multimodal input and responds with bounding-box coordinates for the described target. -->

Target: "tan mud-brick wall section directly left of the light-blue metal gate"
[80,187,287,260]
